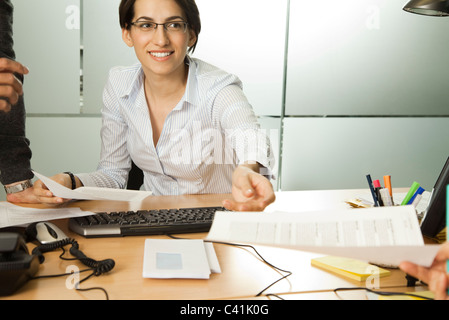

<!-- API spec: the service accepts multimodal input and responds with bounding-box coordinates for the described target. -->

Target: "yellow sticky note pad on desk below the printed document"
[312,256,391,281]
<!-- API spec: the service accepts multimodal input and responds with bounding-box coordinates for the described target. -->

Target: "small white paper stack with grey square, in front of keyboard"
[143,239,221,279]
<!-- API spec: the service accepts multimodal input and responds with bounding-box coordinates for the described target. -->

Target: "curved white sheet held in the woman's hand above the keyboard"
[33,171,151,202]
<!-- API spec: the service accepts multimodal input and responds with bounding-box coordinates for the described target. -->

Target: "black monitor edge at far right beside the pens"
[421,158,449,238]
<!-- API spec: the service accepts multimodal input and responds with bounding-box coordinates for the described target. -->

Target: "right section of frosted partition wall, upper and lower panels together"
[282,0,449,190]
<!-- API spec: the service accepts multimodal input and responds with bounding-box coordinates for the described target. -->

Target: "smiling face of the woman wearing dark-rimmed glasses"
[119,0,197,84]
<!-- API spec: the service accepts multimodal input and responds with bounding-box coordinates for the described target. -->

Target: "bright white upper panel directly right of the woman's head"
[194,0,287,116]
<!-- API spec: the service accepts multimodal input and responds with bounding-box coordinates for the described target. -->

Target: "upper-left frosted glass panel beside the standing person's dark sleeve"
[12,0,80,114]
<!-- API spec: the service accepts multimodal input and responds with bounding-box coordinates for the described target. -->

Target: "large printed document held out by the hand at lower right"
[207,206,439,266]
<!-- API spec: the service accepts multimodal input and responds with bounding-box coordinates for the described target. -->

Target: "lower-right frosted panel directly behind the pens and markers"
[281,118,449,191]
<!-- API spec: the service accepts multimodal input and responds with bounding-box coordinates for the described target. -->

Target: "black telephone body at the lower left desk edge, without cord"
[0,232,40,296]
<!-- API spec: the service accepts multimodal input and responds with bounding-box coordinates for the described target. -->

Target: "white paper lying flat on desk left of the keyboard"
[0,202,95,228]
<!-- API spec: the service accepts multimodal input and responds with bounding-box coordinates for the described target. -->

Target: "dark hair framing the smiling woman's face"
[119,0,201,53]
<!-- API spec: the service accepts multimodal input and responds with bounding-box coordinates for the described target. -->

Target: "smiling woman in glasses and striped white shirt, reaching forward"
[29,0,275,211]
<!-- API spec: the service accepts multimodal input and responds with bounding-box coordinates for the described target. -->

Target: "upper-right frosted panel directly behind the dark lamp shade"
[286,0,449,116]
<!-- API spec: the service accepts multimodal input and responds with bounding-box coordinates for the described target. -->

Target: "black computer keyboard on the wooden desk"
[69,207,226,238]
